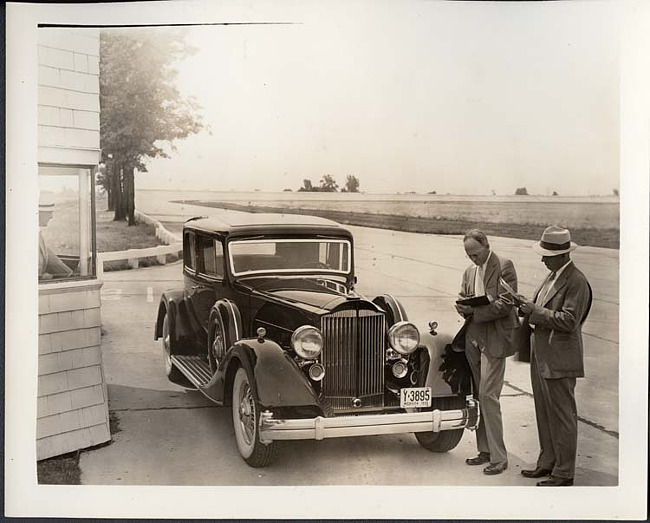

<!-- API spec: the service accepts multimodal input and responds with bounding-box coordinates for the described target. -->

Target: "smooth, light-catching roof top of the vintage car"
[184,213,350,236]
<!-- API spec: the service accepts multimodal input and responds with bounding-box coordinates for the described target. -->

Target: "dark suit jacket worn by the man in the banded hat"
[527,262,592,379]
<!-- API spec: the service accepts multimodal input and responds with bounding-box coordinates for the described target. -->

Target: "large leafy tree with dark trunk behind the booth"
[99,29,203,225]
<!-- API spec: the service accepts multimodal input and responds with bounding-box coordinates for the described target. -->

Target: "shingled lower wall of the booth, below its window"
[36,281,110,459]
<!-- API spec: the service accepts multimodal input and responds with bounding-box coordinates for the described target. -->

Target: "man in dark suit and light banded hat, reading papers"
[519,227,592,487]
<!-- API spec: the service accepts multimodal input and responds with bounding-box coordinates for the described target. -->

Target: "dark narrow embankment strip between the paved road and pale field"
[173,200,620,249]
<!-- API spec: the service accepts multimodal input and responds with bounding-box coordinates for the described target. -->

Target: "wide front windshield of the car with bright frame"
[230,238,351,276]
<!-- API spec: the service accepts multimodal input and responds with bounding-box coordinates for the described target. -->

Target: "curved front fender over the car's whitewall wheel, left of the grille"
[217,338,320,408]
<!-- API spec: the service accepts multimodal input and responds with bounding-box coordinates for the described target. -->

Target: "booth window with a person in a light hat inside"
[38,164,97,283]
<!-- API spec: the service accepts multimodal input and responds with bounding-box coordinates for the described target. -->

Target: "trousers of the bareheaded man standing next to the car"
[465,343,508,464]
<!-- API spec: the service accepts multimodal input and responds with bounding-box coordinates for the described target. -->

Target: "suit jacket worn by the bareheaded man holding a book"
[460,252,519,358]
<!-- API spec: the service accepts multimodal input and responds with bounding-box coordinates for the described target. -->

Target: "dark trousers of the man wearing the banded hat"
[530,335,578,479]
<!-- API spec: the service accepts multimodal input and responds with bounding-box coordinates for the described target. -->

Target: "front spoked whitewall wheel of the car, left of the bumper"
[232,367,276,468]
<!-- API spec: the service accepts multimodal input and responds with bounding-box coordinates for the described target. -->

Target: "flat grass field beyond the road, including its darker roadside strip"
[178,193,620,249]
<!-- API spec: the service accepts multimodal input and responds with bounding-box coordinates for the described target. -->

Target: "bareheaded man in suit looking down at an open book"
[456,229,518,475]
